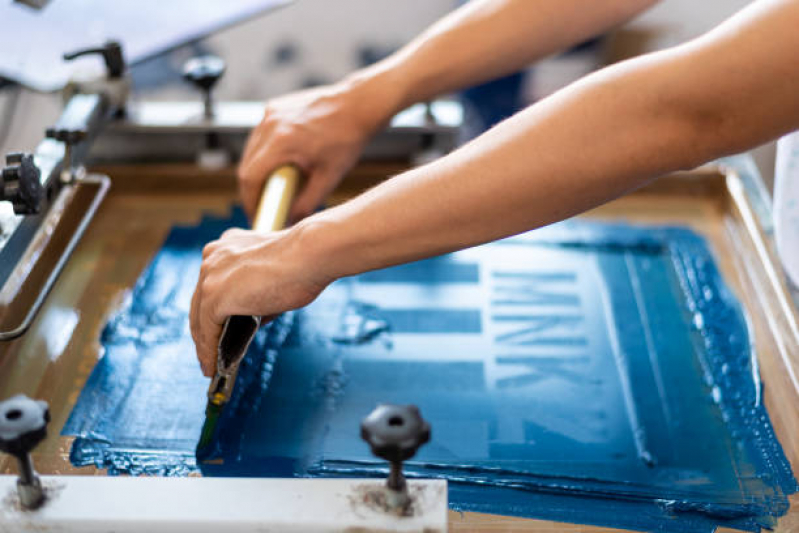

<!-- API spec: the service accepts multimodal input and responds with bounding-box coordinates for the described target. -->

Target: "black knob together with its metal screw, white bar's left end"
[0,394,50,509]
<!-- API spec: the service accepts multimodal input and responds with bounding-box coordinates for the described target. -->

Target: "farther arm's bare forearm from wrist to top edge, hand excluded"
[348,0,657,118]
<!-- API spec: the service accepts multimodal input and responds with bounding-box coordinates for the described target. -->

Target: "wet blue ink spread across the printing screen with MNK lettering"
[63,208,797,533]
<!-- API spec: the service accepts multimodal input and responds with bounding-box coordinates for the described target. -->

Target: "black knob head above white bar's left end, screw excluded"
[0,395,50,457]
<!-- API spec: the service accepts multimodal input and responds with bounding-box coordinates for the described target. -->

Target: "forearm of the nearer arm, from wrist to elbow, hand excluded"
[308,62,697,278]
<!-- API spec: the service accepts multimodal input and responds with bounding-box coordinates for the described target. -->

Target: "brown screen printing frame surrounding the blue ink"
[0,163,799,532]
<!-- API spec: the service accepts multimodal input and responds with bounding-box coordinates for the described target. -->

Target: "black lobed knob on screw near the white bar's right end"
[361,404,430,490]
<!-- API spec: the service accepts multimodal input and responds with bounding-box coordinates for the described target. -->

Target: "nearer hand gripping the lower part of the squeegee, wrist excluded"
[189,226,332,376]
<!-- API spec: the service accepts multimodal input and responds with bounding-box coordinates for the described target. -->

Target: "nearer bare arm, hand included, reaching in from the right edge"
[192,0,799,374]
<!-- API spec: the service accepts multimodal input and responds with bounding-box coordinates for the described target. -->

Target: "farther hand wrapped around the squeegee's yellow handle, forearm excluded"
[238,82,388,223]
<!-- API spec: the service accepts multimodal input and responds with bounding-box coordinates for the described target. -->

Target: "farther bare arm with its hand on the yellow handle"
[239,0,656,220]
